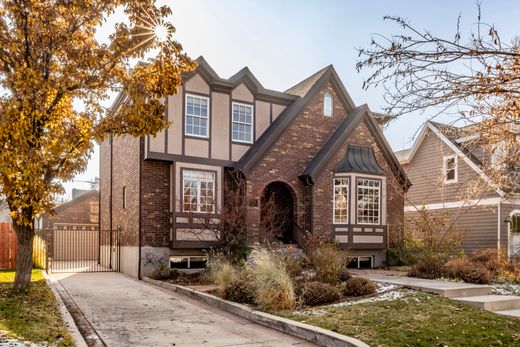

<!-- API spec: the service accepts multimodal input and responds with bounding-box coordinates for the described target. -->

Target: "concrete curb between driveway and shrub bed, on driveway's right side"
[143,277,370,347]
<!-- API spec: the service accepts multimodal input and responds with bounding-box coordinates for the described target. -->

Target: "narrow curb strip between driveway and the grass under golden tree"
[45,275,106,347]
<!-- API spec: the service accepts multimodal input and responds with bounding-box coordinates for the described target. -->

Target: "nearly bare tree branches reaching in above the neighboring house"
[357,3,520,194]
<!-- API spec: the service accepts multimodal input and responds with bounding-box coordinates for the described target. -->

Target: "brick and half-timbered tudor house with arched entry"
[100,57,410,276]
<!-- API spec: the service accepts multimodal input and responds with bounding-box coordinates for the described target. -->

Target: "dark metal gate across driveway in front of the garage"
[42,228,120,273]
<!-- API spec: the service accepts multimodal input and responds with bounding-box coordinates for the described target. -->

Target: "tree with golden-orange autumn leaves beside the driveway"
[0,0,194,291]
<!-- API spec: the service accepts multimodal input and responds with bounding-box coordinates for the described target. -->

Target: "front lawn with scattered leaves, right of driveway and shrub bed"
[284,292,520,347]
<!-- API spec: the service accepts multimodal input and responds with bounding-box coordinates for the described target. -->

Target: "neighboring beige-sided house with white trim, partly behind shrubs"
[395,122,520,256]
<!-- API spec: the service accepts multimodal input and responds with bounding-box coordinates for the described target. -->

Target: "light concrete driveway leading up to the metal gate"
[53,273,314,347]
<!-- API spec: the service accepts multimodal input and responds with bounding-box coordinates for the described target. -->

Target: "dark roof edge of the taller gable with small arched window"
[235,65,355,176]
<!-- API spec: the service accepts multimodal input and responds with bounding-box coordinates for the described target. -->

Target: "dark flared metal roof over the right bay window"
[333,145,385,175]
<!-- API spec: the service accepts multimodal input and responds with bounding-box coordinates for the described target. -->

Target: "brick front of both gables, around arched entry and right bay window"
[247,85,404,245]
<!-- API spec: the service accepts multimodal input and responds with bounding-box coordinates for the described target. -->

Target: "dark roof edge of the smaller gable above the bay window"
[300,105,411,189]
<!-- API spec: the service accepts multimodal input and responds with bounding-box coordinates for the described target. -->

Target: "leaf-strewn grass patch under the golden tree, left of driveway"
[0,270,74,346]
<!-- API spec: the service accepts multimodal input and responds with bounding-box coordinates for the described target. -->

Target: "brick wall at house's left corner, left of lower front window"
[100,136,170,247]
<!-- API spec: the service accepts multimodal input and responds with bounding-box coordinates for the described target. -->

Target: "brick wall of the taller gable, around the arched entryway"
[247,85,348,241]
